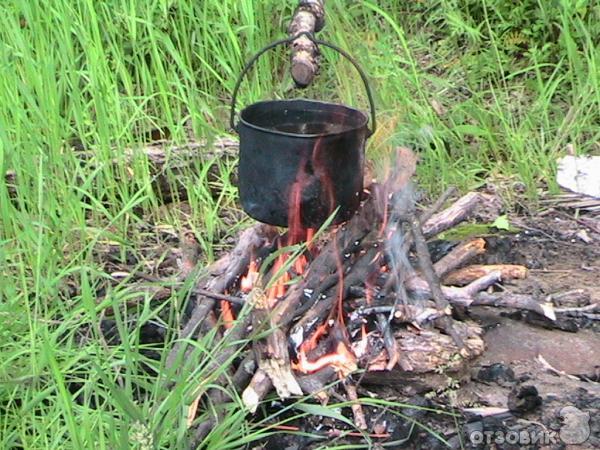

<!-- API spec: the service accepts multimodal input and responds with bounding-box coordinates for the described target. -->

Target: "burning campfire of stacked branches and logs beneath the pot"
[168,148,553,439]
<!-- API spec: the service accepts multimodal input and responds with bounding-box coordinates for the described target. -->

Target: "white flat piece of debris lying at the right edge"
[556,155,600,198]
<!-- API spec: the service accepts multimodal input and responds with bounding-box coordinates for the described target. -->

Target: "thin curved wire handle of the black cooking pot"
[229,31,377,136]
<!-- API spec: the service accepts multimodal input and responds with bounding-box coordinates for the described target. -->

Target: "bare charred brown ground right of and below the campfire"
[332,210,600,449]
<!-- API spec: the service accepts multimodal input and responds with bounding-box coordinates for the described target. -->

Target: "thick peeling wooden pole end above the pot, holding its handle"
[289,0,325,87]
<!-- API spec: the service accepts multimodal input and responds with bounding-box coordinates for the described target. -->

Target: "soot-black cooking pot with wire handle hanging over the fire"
[230,35,375,228]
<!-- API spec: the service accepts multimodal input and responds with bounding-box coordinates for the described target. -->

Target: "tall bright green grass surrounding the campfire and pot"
[0,0,600,449]
